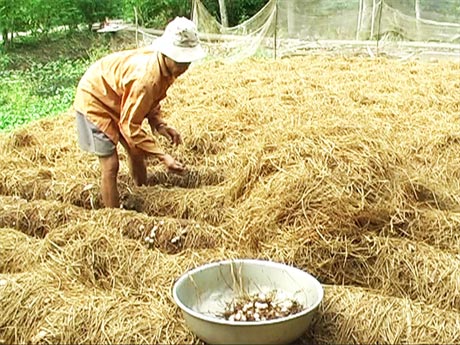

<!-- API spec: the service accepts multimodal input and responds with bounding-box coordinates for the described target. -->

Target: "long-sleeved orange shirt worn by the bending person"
[74,48,174,155]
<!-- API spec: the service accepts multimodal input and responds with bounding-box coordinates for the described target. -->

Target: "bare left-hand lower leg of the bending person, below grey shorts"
[99,151,120,208]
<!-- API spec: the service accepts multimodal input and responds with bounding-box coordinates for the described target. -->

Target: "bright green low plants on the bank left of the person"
[0,32,117,132]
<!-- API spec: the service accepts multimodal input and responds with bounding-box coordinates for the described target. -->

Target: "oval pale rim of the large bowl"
[172,259,324,327]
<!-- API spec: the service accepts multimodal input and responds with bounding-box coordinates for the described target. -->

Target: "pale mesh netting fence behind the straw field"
[192,0,460,62]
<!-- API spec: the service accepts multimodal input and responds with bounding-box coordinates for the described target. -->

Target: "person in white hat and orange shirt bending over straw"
[74,17,205,207]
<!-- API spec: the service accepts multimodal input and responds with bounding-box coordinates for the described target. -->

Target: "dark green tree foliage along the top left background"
[0,0,268,47]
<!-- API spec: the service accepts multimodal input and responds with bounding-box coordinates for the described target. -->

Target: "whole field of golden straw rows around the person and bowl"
[0,56,460,343]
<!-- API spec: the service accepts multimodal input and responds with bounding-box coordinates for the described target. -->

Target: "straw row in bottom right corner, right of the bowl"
[312,286,460,344]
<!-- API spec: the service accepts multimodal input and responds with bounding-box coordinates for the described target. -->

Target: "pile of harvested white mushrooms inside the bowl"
[223,292,303,321]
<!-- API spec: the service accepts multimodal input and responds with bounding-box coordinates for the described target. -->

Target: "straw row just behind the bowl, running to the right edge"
[263,228,460,312]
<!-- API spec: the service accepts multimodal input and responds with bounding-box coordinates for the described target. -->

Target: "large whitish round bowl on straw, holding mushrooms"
[173,259,324,345]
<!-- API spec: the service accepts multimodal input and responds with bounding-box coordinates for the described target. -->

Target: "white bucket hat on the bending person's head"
[152,17,206,62]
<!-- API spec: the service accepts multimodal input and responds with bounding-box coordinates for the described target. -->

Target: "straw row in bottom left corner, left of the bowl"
[0,249,237,344]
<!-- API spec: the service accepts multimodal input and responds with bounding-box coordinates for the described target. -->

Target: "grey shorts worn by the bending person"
[77,111,116,157]
